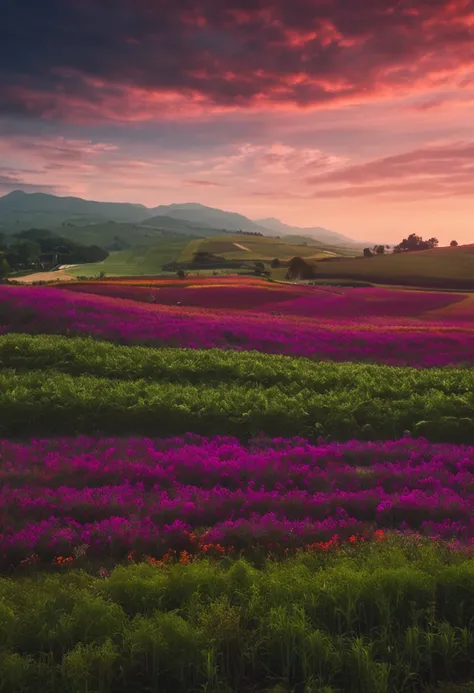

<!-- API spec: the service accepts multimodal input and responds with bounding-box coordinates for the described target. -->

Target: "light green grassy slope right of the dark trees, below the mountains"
[67,237,188,277]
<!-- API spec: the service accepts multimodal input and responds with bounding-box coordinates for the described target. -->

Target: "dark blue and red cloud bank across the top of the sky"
[0,0,474,122]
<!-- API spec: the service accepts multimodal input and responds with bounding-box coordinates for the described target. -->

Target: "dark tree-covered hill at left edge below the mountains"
[0,229,109,277]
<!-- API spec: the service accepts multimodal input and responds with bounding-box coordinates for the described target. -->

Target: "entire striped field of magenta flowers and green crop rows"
[0,278,474,693]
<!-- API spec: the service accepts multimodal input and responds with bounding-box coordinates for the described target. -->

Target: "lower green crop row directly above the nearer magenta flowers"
[0,369,474,442]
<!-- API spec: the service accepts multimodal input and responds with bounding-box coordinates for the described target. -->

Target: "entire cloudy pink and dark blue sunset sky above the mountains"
[0,0,474,244]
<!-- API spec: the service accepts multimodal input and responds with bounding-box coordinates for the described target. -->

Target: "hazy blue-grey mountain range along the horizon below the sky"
[0,190,363,247]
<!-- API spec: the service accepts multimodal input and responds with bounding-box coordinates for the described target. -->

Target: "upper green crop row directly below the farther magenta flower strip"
[0,334,474,403]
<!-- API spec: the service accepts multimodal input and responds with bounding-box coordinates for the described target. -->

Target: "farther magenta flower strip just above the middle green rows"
[0,286,474,367]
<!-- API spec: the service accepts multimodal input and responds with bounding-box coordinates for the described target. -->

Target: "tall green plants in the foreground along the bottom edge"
[0,539,474,693]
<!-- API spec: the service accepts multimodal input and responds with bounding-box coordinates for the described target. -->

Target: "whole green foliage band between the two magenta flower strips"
[0,335,474,443]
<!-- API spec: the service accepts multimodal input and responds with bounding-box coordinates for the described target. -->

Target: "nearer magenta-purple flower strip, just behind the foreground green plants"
[0,436,474,568]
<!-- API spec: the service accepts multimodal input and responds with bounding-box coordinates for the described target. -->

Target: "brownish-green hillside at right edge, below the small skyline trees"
[306,245,474,289]
